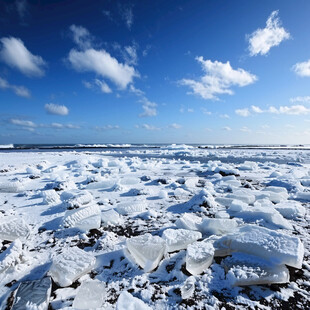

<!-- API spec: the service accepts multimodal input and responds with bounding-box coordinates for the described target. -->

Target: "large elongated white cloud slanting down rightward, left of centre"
[68,48,139,89]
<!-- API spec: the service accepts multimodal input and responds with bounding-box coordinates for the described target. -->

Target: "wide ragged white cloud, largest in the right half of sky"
[179,57,257,100]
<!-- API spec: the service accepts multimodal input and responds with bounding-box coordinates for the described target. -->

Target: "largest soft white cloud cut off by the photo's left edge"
[0,37,46,77]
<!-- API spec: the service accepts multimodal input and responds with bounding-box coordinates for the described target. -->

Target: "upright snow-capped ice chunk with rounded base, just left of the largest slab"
[186,241,214,275]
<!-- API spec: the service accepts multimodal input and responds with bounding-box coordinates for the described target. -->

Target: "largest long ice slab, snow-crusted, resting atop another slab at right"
[214,225,304,268]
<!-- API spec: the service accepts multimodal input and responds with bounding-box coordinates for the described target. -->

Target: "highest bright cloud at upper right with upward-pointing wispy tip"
[249,11,290,56]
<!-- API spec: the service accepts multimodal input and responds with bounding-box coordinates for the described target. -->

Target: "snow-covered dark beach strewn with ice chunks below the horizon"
[0,145,310,309]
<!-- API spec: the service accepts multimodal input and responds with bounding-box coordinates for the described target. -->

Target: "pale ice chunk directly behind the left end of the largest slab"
[198,218,238,235]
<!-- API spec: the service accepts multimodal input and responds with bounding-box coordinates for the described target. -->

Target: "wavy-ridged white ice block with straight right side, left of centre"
[62,205,101,231]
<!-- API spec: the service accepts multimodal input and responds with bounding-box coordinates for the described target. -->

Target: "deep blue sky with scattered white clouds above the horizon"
[0,0,310,144]
